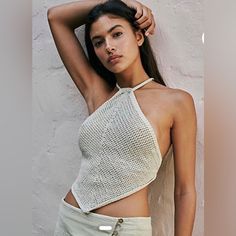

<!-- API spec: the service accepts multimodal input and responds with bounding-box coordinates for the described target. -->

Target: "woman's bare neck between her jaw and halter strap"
[115,57,149,87]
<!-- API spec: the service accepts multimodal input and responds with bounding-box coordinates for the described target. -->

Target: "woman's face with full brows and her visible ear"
[90,14,143,73]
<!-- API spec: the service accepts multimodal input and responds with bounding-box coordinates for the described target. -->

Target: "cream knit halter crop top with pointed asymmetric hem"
[71,78,162,212]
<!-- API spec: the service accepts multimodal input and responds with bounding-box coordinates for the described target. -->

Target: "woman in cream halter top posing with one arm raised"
[48,0,196,236]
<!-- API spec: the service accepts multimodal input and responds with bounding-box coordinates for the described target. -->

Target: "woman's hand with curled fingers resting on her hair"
[122,0,156,36]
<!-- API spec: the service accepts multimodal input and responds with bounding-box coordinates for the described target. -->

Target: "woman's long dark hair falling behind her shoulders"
[85,0,166,88]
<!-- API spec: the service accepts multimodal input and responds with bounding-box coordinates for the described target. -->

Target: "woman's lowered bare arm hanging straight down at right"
[171,89,197,236]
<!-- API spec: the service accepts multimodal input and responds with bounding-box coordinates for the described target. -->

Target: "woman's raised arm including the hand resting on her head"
[47,0,155,113]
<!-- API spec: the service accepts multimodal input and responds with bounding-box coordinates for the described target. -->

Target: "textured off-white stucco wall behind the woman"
[32,0,204,236]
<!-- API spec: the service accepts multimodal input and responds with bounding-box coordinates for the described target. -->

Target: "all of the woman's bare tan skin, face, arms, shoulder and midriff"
[48,0,196,236]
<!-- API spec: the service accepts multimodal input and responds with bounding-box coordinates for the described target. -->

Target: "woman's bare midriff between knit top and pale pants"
[64,187,150,217]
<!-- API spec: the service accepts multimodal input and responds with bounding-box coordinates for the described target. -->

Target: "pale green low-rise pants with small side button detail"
[54,198,152,236]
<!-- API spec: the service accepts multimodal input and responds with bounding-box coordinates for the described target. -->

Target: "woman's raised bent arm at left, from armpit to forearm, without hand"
[47,0,108,106]
